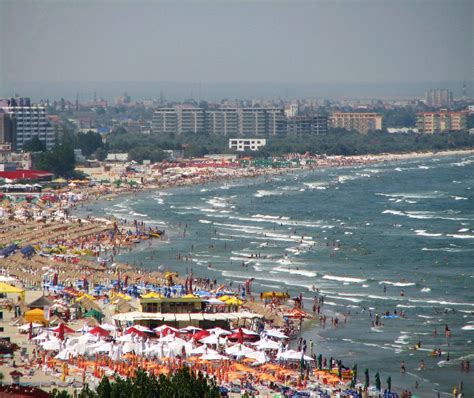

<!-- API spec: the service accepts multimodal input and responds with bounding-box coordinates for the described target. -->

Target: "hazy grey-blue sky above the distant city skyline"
[0,0,474,83]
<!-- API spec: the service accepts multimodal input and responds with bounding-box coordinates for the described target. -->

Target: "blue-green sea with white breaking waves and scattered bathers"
[78,155,474,397]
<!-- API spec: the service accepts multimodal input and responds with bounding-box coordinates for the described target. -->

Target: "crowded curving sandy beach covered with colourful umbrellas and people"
[0,151,468,397]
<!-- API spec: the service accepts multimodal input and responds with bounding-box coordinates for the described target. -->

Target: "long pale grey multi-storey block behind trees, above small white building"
[152,107,286,136]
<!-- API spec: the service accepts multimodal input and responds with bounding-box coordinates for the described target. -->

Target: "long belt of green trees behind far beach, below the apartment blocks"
[107,129,474,160]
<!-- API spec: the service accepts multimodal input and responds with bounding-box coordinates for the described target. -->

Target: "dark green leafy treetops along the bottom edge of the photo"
[50,368,220,398]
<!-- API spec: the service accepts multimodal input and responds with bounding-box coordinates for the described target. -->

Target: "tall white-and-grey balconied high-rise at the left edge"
[2,98,55,151]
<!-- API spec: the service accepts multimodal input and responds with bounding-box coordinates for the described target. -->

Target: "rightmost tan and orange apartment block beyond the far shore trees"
[417,109,467,134]
